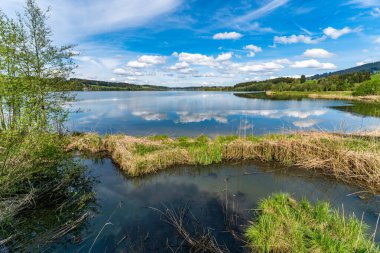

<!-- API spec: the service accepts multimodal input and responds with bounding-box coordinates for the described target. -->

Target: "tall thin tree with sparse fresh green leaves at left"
[0,0,75,131]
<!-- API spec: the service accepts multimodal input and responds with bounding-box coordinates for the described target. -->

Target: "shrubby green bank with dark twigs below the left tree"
[0,131,94,252]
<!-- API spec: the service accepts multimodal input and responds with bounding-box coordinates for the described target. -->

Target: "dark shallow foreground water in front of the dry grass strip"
[48,159,380,252]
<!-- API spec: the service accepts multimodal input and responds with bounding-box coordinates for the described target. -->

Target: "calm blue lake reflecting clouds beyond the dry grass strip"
[67,91,380,136]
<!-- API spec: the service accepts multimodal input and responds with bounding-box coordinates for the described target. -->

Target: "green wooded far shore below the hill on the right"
[234,72,371,92]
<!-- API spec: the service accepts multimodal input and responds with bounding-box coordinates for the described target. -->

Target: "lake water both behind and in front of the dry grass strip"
[29,91,380,252]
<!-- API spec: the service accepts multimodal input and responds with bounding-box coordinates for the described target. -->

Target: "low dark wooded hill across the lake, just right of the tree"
[70,78,169,91]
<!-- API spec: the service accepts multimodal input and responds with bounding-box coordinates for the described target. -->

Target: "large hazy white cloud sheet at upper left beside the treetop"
[1,0,182,42]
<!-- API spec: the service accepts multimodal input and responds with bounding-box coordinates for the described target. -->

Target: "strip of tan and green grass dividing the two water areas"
[68,133,380,192]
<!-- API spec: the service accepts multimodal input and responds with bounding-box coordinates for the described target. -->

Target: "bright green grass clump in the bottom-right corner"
[246,194,380,253]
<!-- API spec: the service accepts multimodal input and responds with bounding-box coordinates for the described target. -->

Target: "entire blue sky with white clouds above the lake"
[0,0,380,87]
